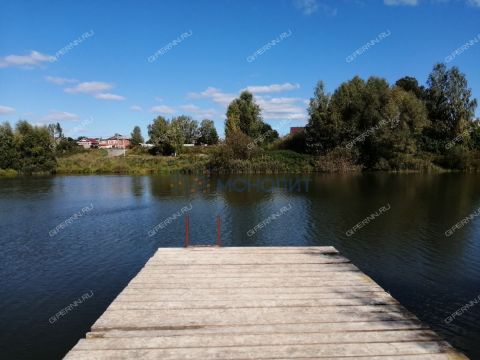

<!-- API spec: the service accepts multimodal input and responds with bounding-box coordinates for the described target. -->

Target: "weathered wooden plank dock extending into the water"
[65,247,467,360]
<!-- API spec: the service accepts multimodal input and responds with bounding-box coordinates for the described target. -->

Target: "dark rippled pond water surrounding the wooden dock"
[0,174,480,359]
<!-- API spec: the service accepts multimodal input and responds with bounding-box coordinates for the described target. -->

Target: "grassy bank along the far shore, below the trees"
[5,148,475,177]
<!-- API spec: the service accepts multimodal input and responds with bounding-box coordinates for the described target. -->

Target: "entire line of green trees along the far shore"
[0,64,480,173]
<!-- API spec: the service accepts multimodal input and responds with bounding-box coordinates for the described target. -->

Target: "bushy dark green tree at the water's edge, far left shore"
[15,120,56,174]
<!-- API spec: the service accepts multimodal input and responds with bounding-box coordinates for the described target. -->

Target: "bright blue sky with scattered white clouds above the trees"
[0,0,480,137]
